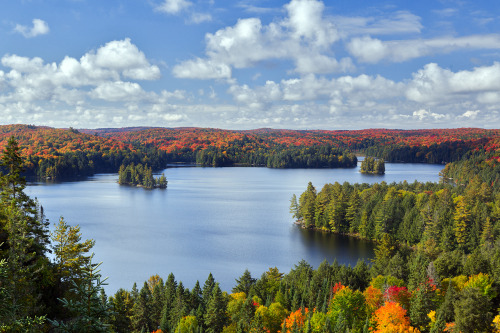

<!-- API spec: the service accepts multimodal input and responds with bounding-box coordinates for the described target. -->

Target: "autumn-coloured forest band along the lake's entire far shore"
[0,125,500,179]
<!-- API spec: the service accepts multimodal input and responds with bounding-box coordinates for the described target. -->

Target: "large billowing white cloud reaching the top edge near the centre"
[173,0,354,79]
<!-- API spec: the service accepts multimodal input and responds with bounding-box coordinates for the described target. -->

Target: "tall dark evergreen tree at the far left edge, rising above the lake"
[0,137,51,323]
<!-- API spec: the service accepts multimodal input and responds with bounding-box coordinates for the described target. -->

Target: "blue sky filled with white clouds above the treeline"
[0,0,500,130]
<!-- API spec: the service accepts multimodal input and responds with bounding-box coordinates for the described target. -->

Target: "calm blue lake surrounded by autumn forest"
[26,163,443,295]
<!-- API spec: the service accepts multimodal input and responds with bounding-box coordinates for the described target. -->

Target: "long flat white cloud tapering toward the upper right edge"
[347,34,500,64]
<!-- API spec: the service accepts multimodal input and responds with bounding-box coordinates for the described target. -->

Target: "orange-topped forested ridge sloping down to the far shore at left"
[0,125,167,180]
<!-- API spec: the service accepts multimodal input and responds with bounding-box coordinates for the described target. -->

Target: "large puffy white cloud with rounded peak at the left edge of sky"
[1,39,160,101]
